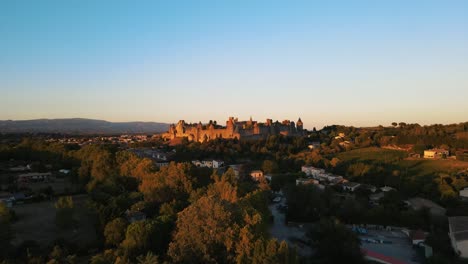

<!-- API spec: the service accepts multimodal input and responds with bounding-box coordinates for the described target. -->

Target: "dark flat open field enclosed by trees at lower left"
[13,195,96,248]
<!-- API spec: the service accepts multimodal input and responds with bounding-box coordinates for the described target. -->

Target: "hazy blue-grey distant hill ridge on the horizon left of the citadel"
[0,118,169,134]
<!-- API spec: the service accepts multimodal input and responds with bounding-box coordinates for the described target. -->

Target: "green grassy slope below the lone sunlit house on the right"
[335,147,468,198]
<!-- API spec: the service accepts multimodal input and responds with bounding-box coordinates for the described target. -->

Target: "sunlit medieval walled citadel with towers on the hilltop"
[163,117,304,142]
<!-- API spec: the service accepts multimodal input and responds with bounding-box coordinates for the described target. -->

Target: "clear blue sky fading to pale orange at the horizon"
[0,0,468,128]
